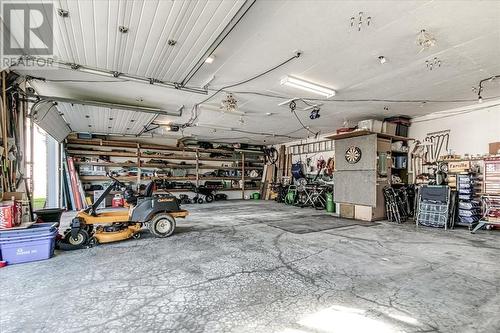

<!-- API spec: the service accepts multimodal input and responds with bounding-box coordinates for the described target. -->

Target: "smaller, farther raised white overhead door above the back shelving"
[58,103,155,135]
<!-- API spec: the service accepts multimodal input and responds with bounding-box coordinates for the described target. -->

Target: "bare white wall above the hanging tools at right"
[409,101,500,155]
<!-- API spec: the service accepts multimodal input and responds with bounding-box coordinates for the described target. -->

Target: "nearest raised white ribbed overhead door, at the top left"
[54,0,245,82]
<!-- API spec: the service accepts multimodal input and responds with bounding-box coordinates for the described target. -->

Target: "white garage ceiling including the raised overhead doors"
[8,0,500,142]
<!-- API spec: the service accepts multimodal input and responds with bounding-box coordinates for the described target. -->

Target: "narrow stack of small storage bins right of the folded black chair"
[457,173,481,227]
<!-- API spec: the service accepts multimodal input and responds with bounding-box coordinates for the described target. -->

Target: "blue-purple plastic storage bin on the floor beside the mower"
[0,223,57,265]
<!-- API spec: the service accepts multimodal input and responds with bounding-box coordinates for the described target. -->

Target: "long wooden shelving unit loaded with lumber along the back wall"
[66,139,265,198]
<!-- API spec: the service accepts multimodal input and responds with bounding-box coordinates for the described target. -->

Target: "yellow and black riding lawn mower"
[63,175,189,248]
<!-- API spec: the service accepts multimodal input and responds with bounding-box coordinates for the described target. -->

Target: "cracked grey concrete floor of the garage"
[0,201,500,333]
